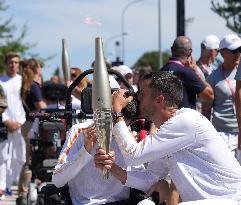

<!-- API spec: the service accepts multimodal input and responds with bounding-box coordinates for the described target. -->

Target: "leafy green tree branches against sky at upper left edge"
[0,0,38,73]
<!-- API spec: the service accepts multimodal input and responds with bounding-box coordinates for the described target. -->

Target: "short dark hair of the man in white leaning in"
[143,71,183,107]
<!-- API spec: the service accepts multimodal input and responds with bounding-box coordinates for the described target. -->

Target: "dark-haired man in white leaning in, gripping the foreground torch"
[95,72,241,205]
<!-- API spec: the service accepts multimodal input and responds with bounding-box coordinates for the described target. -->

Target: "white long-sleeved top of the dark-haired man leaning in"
[113,108,241,201]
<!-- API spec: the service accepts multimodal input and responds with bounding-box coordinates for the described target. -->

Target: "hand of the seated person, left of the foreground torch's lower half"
[84,126,97,154]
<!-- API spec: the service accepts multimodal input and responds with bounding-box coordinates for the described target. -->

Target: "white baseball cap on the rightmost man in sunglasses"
[219,34,241,50]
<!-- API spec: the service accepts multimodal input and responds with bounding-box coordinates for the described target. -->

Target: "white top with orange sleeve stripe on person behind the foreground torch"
[52,121,138,205]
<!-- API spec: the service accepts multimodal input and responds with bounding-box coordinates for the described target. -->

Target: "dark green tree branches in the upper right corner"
[211,0,241,34]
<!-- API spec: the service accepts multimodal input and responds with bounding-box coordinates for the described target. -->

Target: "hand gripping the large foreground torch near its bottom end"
[94,148,115,170]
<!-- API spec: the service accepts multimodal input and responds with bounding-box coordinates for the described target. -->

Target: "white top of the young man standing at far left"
[0,74,26,127]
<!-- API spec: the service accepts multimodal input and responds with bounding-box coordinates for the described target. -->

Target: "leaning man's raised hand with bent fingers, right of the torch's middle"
[112,89,133,112]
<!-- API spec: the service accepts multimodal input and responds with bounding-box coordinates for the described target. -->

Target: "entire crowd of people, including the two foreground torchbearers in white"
[0,34,241,205]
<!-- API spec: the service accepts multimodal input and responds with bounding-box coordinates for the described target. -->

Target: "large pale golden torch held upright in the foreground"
[92,37,112,179]
